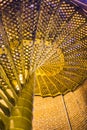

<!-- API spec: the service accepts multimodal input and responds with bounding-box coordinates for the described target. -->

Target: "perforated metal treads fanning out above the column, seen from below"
[0,0,87,96]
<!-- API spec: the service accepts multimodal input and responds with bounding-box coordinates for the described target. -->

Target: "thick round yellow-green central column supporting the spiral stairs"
[9,76,34,130]
